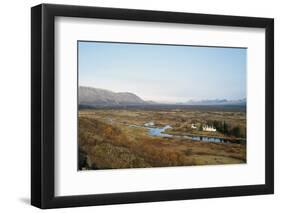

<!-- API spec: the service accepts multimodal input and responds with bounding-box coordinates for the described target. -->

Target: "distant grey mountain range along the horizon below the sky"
[79,86,246,107]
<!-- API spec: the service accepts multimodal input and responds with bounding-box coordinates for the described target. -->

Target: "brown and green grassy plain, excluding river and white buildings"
[79,108,246,170]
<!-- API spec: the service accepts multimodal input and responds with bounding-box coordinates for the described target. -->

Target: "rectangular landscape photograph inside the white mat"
[77,41,247,171]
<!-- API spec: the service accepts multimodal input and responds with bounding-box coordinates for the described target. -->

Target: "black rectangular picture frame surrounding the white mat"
[31,4,274,209]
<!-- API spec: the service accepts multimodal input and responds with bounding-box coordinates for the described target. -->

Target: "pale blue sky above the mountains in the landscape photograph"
[78,41,247,102]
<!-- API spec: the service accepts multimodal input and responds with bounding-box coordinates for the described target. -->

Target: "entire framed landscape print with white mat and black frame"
[31,4,274,208]
